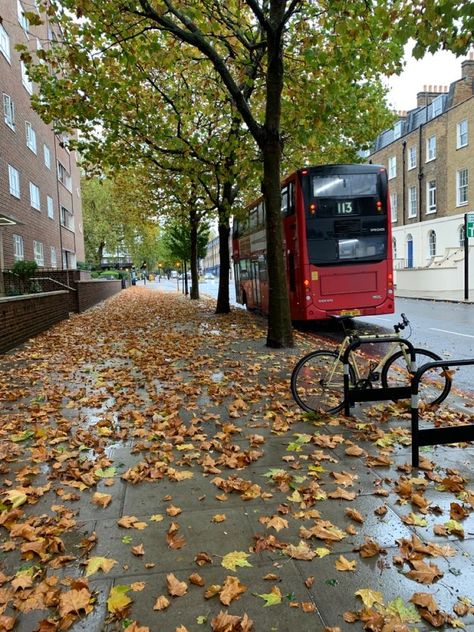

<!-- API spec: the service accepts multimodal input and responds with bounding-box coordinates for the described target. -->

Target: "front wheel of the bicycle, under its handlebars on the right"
[380,349,452,406]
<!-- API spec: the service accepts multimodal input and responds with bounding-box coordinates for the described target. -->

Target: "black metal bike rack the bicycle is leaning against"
[342,336,416,415]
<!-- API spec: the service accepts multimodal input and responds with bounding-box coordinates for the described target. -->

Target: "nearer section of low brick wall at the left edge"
[0,290,69,353]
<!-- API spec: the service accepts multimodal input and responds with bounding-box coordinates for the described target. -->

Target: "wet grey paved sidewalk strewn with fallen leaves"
[0,286,474,632]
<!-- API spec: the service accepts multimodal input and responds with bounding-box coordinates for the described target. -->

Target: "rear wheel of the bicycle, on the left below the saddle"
[291,350,354,413]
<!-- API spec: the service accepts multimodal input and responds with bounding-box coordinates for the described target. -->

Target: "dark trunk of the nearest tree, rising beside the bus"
[259,0,293,348]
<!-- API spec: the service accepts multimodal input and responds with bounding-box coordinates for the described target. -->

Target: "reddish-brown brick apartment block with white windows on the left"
[0,0,85,276]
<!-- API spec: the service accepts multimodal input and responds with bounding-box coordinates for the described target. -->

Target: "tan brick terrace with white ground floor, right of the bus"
[367,54,474,293]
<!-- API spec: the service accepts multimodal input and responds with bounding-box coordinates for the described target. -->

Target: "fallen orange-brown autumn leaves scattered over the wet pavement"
[0,291,474,632]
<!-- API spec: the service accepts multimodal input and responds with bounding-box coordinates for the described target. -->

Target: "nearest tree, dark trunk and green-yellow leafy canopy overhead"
[23,0,473,347]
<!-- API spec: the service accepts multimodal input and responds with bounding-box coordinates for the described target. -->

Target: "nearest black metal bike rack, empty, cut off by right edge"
[410,359,474,467]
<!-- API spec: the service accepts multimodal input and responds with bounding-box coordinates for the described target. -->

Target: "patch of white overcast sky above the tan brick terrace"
[388,45,466,110]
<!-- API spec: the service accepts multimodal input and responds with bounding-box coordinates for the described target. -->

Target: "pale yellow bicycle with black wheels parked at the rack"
[291,314,452,413]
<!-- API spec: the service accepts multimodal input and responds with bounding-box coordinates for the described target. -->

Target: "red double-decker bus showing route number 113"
[232,164,394,321]
